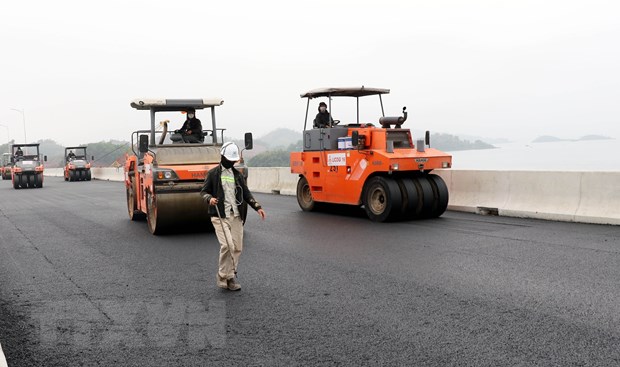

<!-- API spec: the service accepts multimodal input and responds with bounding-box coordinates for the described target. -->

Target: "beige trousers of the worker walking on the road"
[211,216,243,281]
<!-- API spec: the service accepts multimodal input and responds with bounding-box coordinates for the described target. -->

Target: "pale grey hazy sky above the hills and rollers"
[0,0,620,145]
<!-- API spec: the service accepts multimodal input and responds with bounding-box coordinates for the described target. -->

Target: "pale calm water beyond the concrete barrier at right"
[449,139,620,171]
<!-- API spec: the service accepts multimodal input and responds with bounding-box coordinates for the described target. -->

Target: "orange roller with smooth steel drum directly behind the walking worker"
[124,98,252,234]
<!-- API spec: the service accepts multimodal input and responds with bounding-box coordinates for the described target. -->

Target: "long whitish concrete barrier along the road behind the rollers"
[45,167,620,225]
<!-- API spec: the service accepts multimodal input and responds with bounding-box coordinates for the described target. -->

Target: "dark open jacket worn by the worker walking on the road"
[200,165,261,218]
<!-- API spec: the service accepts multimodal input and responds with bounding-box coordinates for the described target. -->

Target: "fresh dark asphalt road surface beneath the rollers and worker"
[0,177,620,366]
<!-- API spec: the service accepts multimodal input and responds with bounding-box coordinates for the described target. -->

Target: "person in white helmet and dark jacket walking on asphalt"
[200,142,265,291]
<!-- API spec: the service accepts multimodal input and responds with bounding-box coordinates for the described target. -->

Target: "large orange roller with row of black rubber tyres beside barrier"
[290,87,452,222]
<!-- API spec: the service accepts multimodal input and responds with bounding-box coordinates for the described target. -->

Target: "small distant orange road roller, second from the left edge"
[11,144,47,189]
